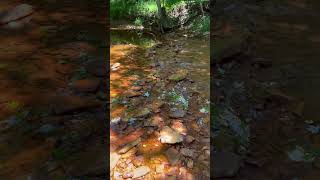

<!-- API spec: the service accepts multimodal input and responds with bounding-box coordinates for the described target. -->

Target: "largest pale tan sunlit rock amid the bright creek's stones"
[160,126,183,144]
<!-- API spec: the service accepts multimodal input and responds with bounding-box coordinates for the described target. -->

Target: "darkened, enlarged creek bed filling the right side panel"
[211,0,320,180]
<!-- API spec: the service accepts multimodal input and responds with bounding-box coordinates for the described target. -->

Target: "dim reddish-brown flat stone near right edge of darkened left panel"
[72,79,101,93]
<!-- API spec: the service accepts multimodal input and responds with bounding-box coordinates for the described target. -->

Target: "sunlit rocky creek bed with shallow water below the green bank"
[110,25,210,179]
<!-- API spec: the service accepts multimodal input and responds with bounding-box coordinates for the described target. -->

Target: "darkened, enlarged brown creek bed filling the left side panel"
[0,0,108,179]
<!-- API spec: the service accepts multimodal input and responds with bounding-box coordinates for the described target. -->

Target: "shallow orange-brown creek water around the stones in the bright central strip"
[110,29,210,179]
